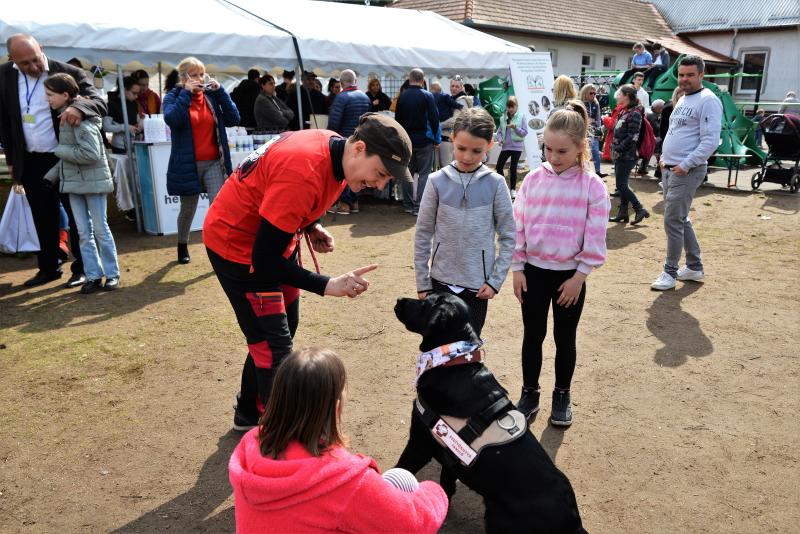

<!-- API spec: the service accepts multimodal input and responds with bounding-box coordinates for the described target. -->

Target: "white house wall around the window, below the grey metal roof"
[687,26,800,105]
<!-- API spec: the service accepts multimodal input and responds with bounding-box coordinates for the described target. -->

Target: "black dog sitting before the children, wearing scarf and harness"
[394,293,585,533]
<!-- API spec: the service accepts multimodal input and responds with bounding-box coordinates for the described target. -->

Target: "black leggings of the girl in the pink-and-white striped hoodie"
[522,263,586,389]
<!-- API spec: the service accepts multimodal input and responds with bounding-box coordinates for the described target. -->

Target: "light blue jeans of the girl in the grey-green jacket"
[69,193,119,280]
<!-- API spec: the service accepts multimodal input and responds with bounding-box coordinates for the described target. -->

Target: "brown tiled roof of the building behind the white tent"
[391,0,736,63]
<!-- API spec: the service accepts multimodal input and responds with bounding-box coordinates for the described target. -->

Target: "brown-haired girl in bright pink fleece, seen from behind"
[228,348,447,533]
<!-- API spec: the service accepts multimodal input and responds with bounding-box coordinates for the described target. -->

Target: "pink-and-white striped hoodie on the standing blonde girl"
[511,163,611,274]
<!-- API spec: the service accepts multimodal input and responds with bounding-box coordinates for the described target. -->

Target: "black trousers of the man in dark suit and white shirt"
[22,152,83,274]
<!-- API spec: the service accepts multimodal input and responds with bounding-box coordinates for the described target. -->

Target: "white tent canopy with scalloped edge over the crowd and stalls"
[0,0,528,77]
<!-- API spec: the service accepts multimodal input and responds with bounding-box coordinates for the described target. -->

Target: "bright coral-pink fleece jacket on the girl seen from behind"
[228,428,447,534]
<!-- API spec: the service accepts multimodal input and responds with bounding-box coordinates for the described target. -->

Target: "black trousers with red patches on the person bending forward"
[206,249,300,416]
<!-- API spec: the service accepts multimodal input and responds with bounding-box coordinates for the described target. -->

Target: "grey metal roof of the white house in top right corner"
[650,0,800,33]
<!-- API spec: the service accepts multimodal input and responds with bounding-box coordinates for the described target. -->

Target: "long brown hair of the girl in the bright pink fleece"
[258,347,347,459]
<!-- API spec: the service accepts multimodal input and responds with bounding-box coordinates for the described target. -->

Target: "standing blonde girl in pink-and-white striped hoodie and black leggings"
[511,100,610,426]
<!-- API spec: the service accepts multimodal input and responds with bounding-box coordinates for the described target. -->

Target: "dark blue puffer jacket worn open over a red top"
[164,86,239,195]
